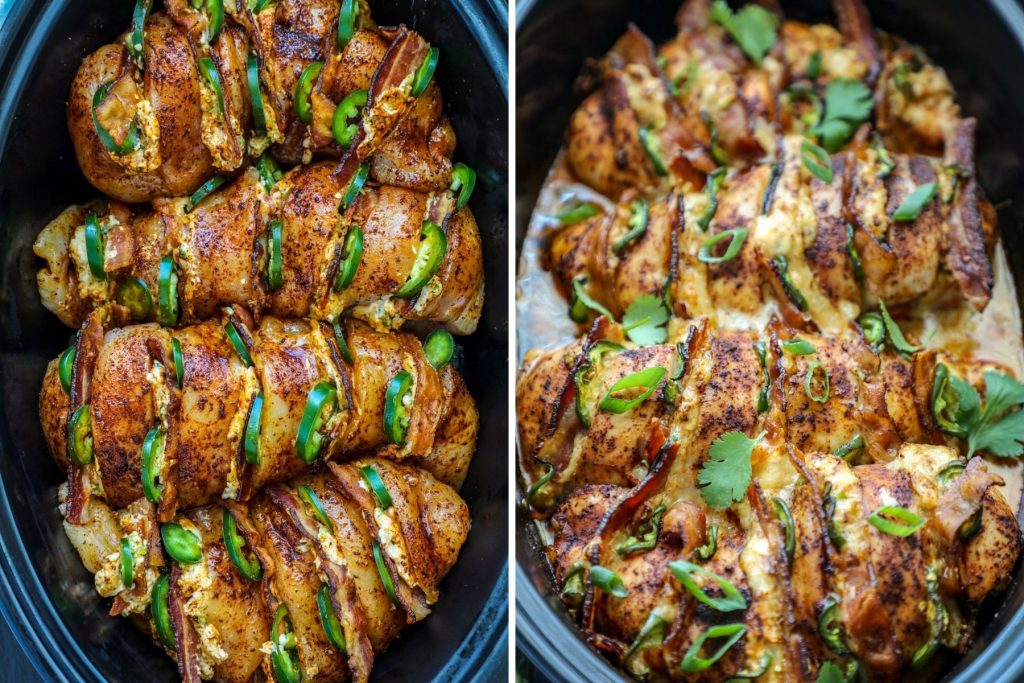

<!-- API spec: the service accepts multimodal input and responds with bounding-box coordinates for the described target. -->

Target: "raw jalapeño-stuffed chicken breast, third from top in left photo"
[40,308,478,521]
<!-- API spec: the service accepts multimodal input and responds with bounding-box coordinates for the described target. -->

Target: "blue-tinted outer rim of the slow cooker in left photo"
[0,0,509,683]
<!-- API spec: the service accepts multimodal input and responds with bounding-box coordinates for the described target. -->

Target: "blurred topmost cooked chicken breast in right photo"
[565,0,959,200]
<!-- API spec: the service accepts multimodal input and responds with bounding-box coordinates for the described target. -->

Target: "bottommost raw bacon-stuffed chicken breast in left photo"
[61,458,469,683]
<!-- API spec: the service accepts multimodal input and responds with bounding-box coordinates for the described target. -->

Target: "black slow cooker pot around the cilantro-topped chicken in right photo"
[515,0,1024,683]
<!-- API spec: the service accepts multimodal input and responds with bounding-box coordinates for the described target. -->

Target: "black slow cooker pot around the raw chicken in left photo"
[0,0,508,682]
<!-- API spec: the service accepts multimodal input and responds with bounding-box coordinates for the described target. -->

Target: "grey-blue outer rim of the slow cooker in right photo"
[515,0,1024,683]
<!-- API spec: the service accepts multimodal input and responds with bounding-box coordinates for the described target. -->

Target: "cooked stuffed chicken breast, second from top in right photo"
[546,125,997,334]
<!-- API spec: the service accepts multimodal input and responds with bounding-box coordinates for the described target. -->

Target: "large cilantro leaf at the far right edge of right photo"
[949,371,1024,458]
